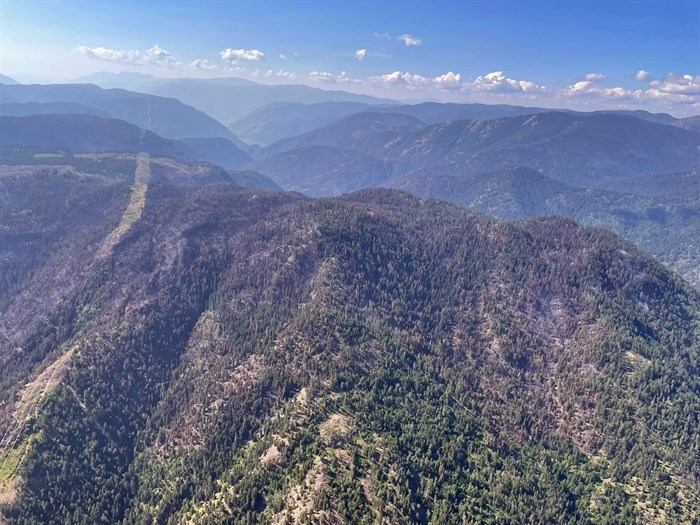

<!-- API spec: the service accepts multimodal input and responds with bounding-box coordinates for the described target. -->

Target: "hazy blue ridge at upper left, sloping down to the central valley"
[0,84,235,140]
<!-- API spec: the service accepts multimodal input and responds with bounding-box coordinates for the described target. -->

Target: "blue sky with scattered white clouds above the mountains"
[0,0,700,116]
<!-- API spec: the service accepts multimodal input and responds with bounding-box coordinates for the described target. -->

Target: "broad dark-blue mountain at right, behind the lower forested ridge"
[388,112,698,187]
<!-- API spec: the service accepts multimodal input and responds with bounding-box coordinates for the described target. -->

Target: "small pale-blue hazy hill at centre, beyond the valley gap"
[229,102,373,146]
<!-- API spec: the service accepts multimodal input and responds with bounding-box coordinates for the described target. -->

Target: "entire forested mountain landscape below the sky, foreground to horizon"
[0,74,700,525]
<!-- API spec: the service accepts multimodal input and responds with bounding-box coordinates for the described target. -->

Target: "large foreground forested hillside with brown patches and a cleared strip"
[0,158,700,524]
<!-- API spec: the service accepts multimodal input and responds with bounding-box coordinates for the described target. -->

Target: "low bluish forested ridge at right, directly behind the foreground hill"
[398,166,700,288]
